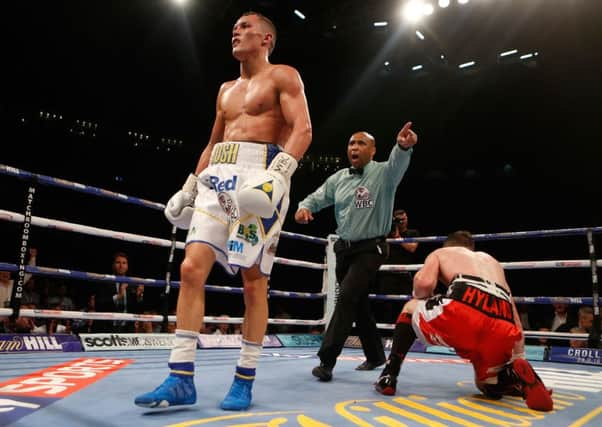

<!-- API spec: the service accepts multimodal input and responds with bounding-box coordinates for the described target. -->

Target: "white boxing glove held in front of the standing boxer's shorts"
[238,151,297,218]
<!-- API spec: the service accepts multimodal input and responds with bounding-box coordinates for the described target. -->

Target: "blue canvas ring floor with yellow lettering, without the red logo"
[0,348,602,427]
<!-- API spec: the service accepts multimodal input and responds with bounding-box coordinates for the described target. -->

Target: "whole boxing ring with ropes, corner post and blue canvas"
[0,165,602,427]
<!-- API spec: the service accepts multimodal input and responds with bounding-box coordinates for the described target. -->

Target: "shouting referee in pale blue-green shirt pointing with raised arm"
[295,122,418,381]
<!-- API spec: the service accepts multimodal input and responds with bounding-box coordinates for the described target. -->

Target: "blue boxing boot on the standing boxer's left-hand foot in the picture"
[134,362,196,408]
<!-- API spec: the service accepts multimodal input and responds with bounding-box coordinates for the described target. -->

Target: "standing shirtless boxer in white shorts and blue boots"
[135,12,312,410]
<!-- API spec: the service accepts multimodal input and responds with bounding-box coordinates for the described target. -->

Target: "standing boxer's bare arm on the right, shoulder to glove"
[273,65,312,160]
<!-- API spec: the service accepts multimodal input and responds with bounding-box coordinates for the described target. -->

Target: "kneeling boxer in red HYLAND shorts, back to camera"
[375,231,554,411]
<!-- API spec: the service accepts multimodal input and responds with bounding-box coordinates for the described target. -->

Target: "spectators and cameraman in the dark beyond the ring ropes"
[0,222,594,348]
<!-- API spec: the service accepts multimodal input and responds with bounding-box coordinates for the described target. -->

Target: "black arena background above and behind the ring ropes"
[0,0,602,314]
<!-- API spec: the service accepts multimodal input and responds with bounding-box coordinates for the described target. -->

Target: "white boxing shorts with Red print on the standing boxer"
[186,142,289,276]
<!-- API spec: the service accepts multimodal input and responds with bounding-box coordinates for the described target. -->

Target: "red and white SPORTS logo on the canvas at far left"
[0,358,132,426]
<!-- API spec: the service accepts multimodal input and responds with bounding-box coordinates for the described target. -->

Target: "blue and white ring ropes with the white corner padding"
[0,164,602,348]
